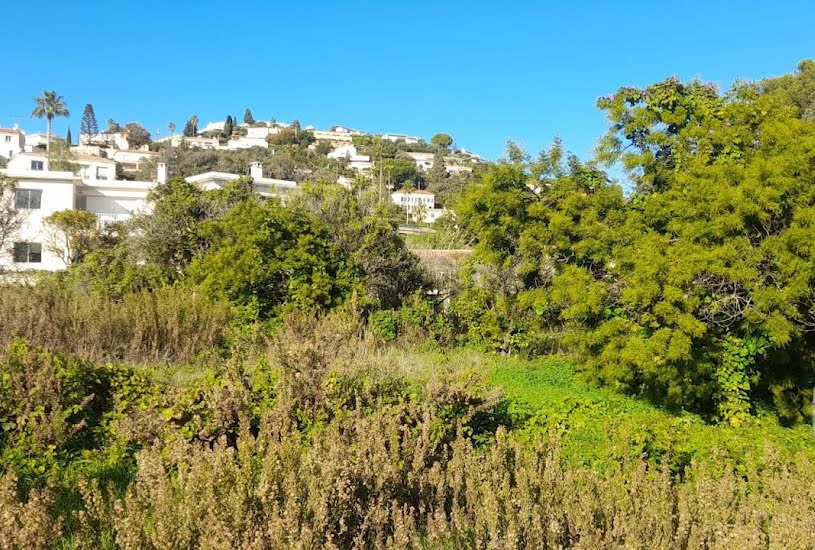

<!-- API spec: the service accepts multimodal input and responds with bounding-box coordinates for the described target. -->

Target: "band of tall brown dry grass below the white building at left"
[0,283,234,362]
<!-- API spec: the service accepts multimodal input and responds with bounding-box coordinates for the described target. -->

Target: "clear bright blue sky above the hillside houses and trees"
[0,0,815,162]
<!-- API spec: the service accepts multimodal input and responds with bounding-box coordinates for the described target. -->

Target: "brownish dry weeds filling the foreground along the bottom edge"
[46,424,815,549]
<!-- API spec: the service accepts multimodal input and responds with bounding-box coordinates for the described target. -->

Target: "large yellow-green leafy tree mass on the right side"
[454,69,815,424]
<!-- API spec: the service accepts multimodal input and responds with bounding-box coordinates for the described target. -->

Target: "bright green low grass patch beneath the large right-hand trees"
[487,357,815,474]
